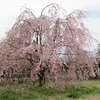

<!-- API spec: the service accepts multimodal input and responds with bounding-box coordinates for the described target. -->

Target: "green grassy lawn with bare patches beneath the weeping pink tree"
[0,80,100,100]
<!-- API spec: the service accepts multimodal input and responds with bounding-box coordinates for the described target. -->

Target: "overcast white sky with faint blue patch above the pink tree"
[0,0,100,48]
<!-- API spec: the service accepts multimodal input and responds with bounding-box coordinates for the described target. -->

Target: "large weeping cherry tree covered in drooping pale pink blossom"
[0,3,95,86]
